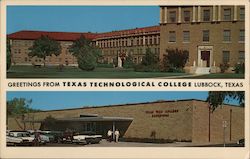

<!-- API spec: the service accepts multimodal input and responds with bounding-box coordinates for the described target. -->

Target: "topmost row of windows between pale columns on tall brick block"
[168,8,245,23]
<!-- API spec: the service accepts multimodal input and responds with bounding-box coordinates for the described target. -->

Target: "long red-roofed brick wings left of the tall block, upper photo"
[8,26,160,67]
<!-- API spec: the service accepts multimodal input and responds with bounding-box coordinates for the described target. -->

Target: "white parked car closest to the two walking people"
[73,133,102,144]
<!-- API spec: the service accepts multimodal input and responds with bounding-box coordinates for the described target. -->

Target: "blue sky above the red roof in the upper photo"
[7,6,160,34]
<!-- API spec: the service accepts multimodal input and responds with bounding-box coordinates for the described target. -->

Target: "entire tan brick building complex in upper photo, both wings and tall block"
[8,6,245,73]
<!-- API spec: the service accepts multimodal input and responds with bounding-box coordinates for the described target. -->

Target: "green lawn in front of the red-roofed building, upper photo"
[7,66,188,78]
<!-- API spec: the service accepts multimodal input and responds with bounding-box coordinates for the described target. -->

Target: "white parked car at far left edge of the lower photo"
[7,131,34,146]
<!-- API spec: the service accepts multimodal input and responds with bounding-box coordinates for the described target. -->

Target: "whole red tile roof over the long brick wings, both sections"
[8,26,160,41]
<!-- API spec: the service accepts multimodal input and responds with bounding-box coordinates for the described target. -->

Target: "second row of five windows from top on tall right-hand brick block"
[168,29,245,42]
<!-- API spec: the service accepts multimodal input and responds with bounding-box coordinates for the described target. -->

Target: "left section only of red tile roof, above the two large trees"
[8,30,96,41]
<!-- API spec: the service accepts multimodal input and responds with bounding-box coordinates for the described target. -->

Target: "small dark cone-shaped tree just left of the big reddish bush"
[142,48,159,66]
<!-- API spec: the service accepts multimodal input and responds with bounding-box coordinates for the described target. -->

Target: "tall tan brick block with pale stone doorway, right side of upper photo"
[160,6,245,72]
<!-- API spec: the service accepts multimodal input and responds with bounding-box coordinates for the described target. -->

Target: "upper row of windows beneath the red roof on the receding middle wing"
[97,36,160,48]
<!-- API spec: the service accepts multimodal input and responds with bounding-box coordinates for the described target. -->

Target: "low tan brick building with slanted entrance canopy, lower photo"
[8,99,245,143]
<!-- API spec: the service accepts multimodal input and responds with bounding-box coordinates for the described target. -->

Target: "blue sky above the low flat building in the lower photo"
[7,91,212,110]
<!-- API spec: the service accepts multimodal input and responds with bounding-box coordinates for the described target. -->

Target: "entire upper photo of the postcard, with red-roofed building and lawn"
[6,5,246,79]
